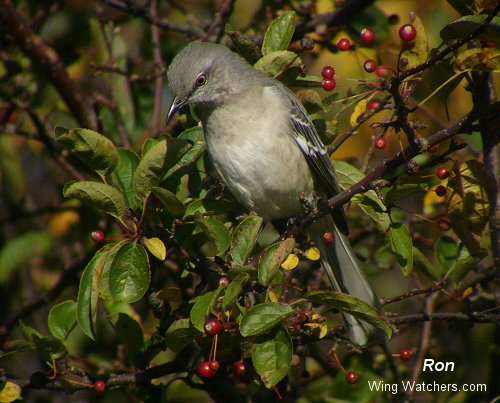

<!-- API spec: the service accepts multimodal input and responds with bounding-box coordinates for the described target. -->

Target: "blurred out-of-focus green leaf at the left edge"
[0,231,53,284]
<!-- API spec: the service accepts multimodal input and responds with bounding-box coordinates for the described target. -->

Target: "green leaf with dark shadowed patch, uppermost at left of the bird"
[55,126,118,176]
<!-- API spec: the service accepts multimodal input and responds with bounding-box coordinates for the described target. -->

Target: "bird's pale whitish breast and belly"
[203,83,314,218]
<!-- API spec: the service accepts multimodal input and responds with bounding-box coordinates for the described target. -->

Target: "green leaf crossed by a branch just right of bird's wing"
[332,160,391,231]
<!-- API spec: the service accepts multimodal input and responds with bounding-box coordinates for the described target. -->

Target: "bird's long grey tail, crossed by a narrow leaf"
[309,216,383,346]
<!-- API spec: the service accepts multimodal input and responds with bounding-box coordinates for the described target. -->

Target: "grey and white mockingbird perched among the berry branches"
[167,42,378,345]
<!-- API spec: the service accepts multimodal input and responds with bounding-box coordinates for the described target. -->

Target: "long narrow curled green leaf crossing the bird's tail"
[304,291,392,338]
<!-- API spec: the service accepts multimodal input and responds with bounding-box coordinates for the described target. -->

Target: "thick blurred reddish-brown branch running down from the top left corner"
[0,0,98,130]
